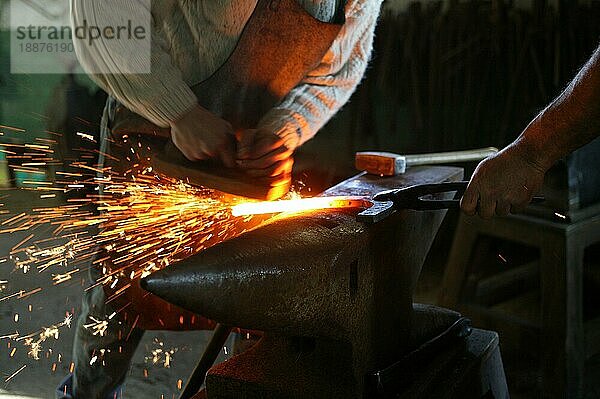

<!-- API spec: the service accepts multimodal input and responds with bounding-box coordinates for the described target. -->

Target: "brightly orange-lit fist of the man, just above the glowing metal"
[237,129,294,186]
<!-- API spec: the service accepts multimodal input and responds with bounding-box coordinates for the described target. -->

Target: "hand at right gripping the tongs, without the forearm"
[461,141,546,219]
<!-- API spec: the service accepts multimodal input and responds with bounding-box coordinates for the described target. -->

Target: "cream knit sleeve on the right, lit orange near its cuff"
[259,0,382,149]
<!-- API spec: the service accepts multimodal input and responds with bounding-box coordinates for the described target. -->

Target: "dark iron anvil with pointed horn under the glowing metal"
[143,167,463,398]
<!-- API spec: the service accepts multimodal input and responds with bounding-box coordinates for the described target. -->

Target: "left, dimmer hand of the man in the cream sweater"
[171,105,235,167]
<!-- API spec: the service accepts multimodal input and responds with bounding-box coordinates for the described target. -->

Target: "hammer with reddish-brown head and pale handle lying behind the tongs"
[355,147,498,176]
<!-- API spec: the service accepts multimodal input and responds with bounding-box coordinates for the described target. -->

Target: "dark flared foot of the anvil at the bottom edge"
[206,333,356,399]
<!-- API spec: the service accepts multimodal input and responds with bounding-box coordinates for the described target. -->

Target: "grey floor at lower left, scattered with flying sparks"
[0,192,229,399]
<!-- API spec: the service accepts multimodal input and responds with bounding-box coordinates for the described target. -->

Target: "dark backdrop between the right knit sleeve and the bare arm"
[304,0,600,189]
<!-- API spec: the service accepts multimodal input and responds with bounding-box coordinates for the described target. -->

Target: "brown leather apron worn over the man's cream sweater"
[100,0,343,330]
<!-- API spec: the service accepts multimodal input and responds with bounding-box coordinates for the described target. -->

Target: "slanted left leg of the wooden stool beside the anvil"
[438,215,478,309]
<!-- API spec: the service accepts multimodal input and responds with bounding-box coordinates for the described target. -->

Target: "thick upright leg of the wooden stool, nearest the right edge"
[540,235,585,398]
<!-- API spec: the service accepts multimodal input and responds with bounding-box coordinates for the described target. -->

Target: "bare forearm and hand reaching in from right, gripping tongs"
[462,47,600,218]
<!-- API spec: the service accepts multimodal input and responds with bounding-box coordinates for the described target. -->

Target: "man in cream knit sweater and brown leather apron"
[59,0,382,399]
